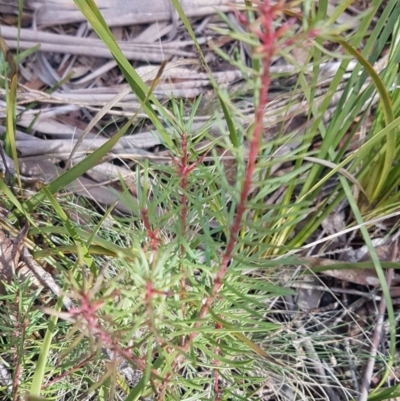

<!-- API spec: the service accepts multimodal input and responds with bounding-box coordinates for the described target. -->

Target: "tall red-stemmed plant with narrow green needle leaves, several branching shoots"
[34,1,322,400]
